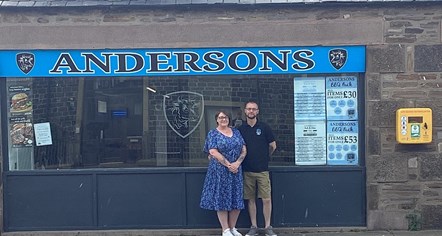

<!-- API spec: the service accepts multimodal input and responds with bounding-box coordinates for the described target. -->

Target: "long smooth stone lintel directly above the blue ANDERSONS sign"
[0,18,384,49]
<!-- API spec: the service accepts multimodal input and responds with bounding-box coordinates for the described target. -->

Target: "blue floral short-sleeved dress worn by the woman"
[200,128,245,211]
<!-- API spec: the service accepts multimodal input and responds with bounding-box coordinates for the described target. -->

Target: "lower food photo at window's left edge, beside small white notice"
[9,123,34,147]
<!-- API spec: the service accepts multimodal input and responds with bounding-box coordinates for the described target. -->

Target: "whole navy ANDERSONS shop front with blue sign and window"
[0,46,366,231]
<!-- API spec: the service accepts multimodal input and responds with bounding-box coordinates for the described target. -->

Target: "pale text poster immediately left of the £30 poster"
[294,77,326,121]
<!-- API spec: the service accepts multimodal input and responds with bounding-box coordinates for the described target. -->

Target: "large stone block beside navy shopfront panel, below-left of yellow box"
[366,153,408,183]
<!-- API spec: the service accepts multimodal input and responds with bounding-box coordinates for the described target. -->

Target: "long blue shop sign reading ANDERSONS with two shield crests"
[0,46,365,77]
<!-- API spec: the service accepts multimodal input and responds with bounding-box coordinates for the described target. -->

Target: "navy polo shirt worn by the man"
[238,120,275,172]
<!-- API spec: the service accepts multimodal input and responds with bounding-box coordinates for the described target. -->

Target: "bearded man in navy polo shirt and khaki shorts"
[239,101,276,236]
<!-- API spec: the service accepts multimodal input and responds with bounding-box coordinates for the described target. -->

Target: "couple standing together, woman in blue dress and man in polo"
[200,101,276,236]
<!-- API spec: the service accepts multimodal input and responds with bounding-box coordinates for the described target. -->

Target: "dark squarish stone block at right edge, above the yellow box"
[414,44,442,72]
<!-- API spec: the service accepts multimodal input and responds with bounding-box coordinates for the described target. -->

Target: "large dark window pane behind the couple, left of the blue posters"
[6,75,360,170]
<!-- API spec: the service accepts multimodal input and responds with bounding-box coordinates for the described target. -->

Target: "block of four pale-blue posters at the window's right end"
[294,76,359,165]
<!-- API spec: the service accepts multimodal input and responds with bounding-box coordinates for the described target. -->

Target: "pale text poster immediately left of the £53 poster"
[295,121,327,165]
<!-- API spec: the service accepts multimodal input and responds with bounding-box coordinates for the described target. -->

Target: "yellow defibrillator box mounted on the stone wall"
[396,108,433,144]
